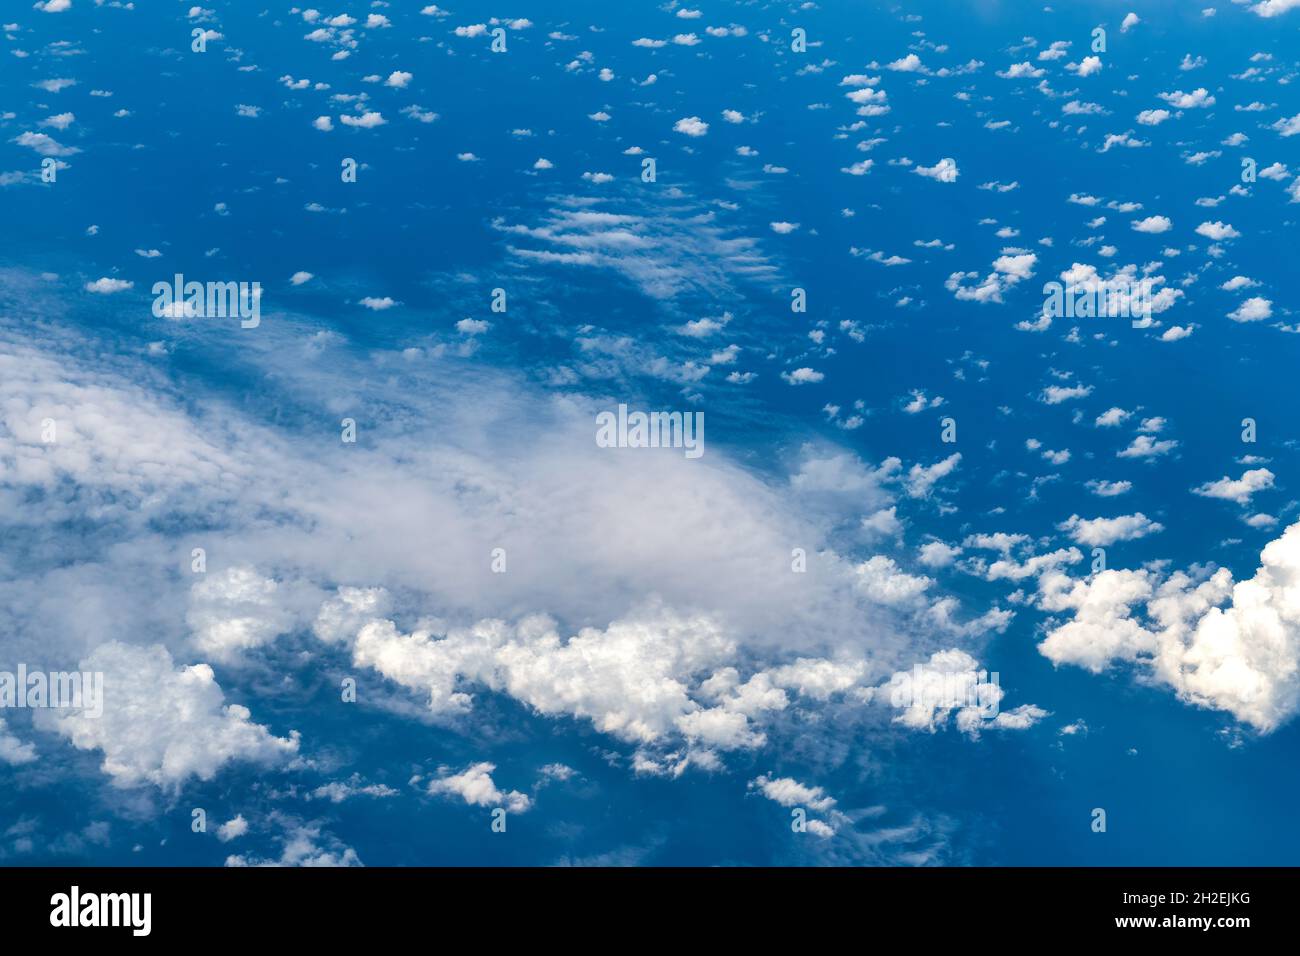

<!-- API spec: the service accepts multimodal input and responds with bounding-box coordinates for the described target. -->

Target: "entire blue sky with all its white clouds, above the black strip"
[0,0,1300,866]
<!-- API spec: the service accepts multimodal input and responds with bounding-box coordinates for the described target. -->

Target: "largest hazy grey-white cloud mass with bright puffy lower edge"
[0,282,1024,788]
